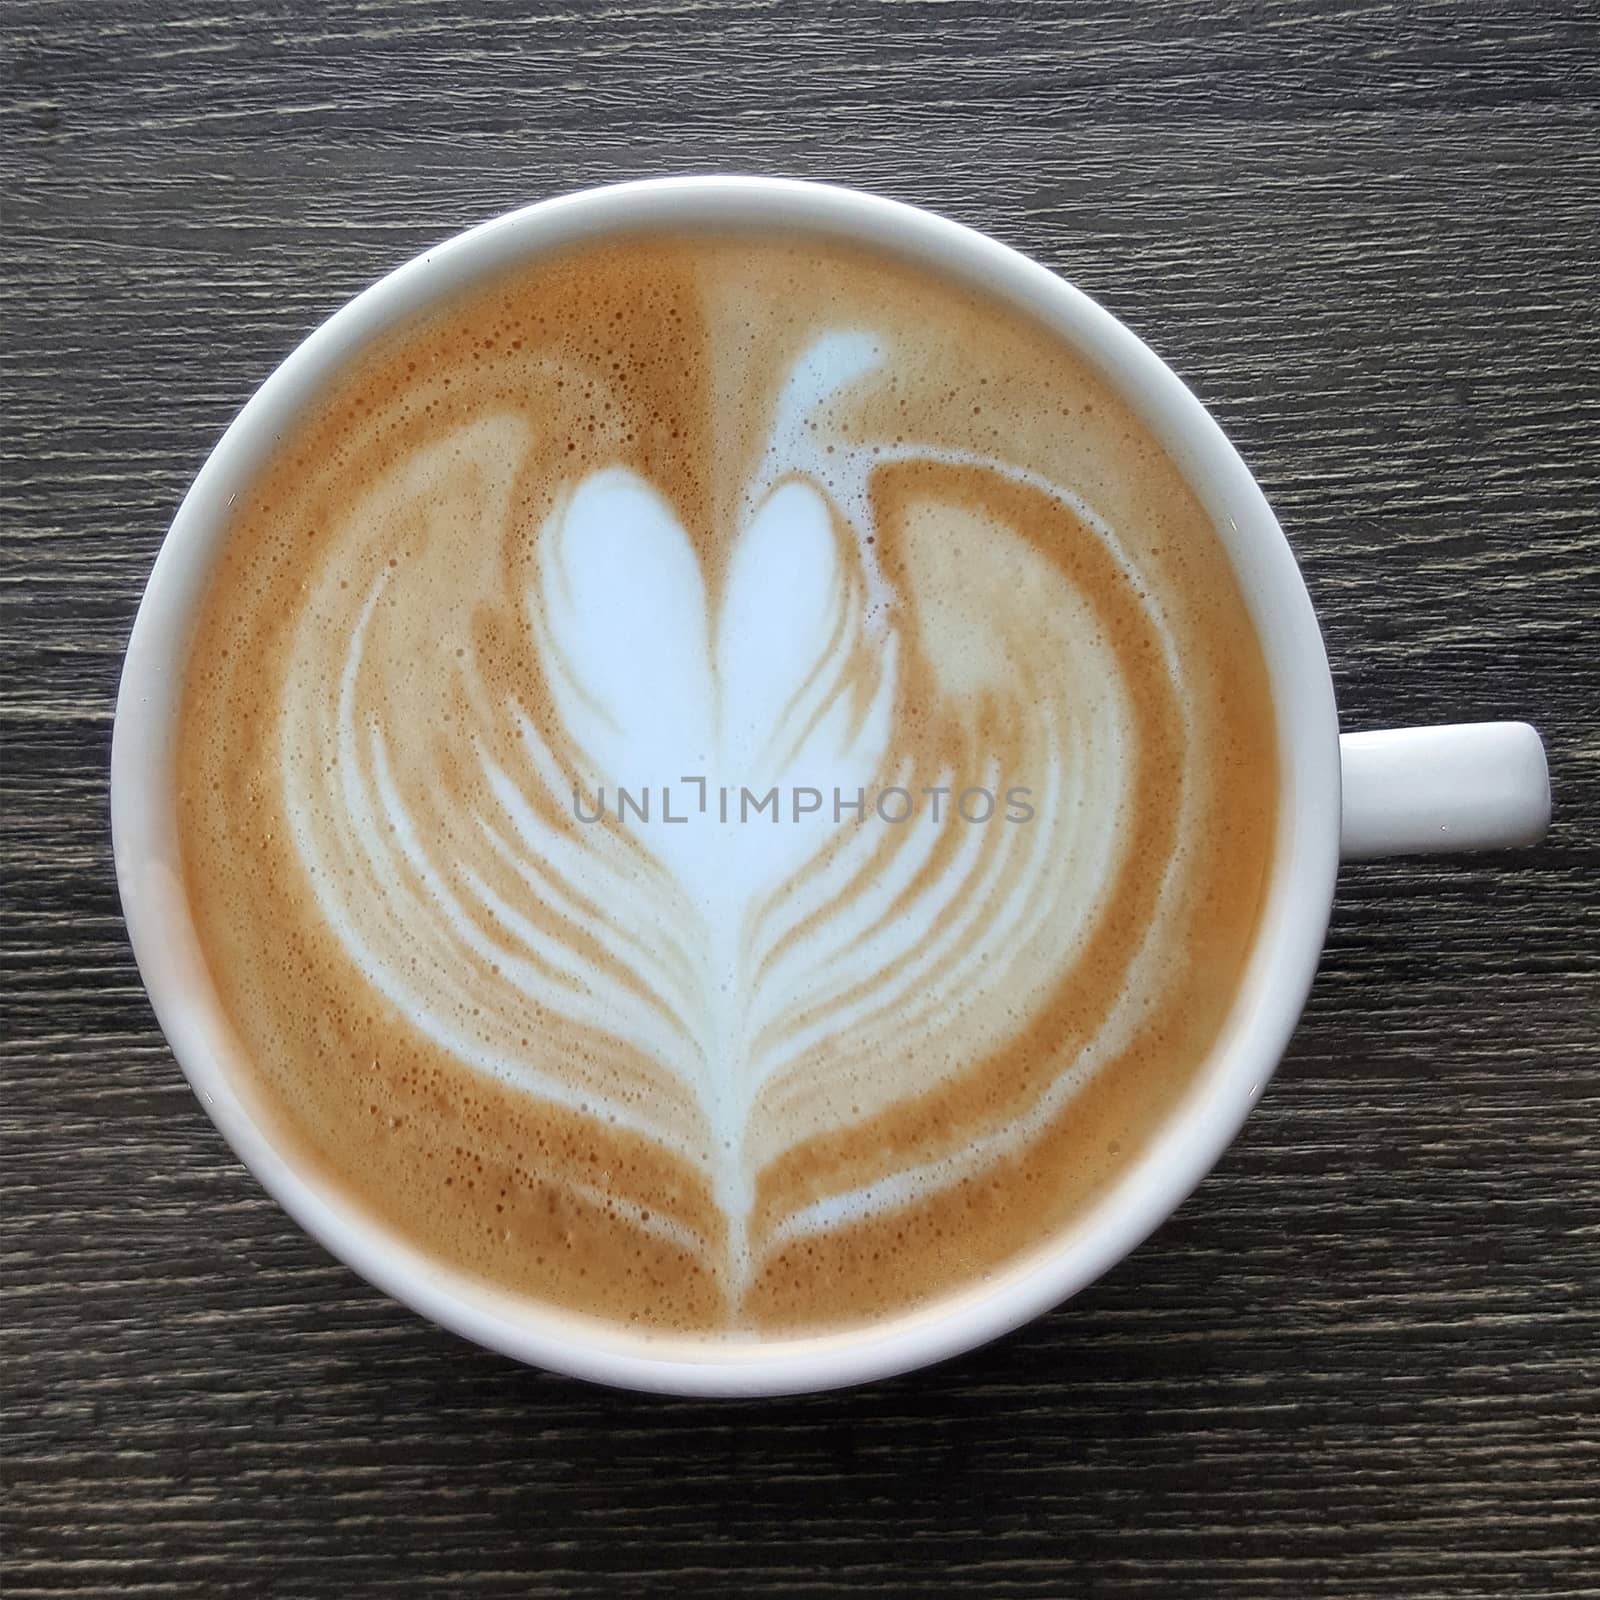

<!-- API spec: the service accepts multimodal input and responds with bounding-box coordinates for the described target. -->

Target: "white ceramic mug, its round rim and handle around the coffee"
[112,178,1550,1395]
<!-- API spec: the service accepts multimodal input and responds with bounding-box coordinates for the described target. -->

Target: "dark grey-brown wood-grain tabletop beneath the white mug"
[0,0,1600,1600]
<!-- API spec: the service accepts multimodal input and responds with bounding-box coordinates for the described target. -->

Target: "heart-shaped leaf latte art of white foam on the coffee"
[277,331,1194,1306]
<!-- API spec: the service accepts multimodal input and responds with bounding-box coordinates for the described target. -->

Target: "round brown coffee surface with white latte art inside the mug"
[178,232,1278,1338]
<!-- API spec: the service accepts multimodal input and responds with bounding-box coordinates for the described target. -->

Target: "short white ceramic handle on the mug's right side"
[1339,722,1550,861]
